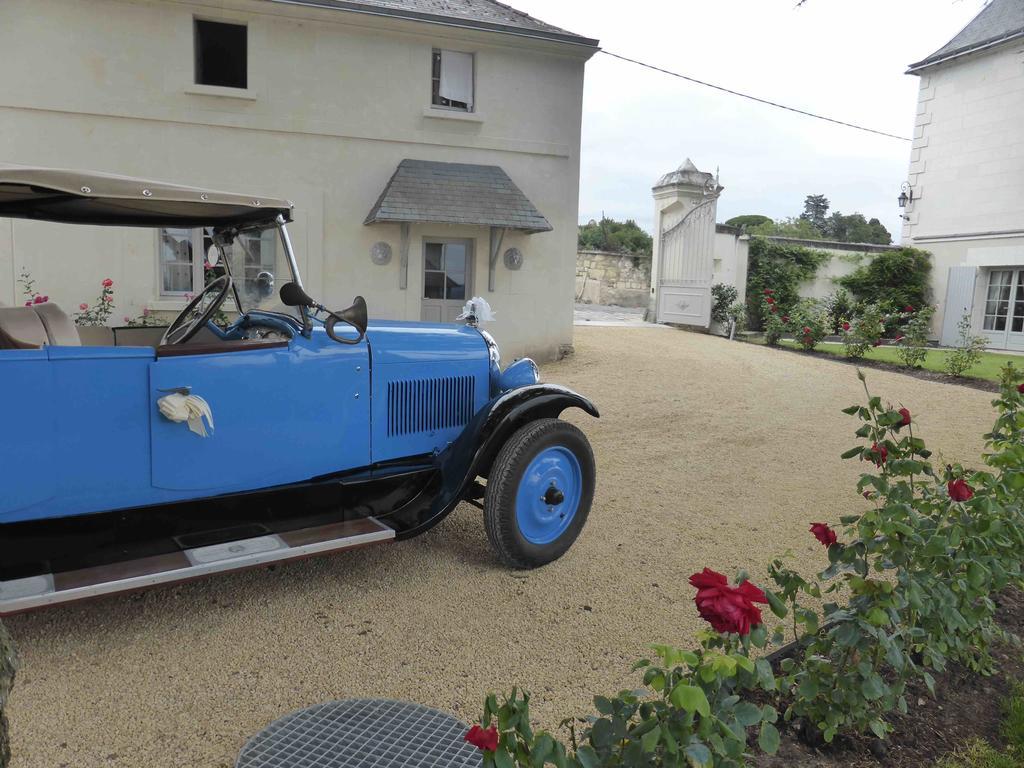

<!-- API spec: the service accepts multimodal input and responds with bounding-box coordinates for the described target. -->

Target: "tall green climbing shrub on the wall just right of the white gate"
[746,238,831,331]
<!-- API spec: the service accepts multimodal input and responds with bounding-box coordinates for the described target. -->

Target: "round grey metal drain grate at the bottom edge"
[234,698,483,768]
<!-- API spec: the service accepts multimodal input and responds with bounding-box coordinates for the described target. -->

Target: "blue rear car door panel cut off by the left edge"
[0,349,55,522]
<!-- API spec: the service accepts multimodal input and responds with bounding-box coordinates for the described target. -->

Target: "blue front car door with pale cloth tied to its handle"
[150,334,370,494]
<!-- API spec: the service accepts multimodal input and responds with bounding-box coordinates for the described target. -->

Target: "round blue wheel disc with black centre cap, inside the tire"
[515,445,583,545]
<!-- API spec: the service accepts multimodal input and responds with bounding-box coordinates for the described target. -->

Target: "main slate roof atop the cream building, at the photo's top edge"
[271,0,598,47]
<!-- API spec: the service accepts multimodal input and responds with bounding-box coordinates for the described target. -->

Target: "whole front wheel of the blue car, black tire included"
[483,419,596,568]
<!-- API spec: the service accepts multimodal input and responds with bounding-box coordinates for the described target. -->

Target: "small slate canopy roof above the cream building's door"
[362,160,552,232]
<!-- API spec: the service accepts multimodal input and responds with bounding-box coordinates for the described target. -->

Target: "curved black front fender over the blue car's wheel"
[395,384,600,539]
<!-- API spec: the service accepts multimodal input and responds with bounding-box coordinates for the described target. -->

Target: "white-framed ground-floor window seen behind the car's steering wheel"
[157,227,278,297]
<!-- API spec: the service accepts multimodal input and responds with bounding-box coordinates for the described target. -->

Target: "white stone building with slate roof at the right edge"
[902,0,1024,349]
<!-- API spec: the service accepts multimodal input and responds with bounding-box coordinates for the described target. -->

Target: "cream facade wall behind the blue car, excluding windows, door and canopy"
[0,0,591,358]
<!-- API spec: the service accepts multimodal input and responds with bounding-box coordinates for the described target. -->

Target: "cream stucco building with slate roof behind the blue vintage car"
[0,0,597,358]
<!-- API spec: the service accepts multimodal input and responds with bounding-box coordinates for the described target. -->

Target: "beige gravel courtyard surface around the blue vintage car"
[2,328,992,768]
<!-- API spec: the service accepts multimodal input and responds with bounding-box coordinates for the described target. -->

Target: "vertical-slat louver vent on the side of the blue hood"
[387,376,475,437]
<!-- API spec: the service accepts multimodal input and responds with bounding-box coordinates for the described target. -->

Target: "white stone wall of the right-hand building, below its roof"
[894,41,1024,342]
